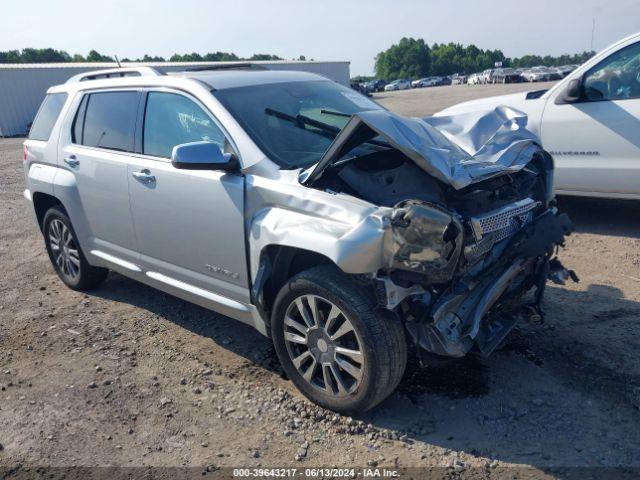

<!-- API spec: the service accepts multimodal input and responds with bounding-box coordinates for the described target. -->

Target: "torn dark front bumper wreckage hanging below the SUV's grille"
[406,210,577,357]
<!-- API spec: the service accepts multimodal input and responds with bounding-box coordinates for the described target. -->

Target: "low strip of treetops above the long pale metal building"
[0,48,306,63]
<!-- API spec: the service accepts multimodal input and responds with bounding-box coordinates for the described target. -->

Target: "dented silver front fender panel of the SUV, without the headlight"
[246,170,393,282]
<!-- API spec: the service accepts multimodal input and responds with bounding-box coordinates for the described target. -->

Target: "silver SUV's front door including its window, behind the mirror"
[129,91,249,310]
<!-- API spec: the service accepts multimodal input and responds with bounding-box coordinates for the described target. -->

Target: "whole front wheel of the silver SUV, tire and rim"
[271,266,407,414]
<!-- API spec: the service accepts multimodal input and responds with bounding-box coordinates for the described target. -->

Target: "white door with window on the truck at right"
[541,42,640,197]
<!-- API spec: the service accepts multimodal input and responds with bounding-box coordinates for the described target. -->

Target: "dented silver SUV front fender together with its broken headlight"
[246,171,463,290]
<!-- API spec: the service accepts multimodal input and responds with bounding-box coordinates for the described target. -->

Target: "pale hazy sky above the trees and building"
[0,0,640,75]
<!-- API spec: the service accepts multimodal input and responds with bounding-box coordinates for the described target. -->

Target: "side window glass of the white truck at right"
[584,42,640,100]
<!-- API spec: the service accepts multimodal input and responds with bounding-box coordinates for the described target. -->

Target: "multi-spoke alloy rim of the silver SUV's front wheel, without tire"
[284,295,365,397]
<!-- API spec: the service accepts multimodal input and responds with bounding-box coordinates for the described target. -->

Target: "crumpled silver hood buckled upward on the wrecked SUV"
[303,106,540,189]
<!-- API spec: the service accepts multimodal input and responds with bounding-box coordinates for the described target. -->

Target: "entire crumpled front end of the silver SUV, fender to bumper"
[247,107,575,357]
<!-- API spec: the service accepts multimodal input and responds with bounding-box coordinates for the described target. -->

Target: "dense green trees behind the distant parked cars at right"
[375,38,595,80]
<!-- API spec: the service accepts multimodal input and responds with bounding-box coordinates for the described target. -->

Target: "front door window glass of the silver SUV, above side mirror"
[142,92,225,158]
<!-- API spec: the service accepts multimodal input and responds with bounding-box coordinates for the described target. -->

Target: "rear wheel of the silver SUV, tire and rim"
[42,207,109,290]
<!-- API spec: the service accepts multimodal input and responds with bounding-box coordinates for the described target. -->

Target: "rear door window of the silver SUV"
[73,92,140,152]
